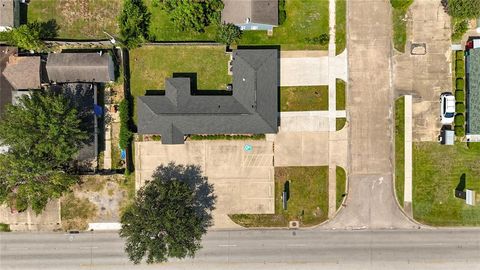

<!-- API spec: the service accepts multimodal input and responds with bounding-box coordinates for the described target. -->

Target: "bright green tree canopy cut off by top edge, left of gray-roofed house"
[163,0,223,32]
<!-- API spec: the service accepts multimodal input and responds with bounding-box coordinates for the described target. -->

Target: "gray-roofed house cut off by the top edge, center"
[222,0,278,31]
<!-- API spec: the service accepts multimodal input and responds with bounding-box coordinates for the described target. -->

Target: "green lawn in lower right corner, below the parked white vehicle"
[413,142,480,226]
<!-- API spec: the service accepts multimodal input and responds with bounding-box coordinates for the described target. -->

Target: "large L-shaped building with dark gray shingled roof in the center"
[137,49,279,144]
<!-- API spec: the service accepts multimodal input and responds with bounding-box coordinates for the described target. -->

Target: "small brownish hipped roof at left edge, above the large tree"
[3,55,47,90]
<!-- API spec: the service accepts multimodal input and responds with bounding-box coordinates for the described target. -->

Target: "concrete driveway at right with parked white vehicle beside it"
[394,0,454,141]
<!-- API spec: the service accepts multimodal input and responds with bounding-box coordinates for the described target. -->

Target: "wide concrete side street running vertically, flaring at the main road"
[325,0,416,229]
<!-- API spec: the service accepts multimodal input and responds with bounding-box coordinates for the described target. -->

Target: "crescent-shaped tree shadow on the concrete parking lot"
[152,162,216,227]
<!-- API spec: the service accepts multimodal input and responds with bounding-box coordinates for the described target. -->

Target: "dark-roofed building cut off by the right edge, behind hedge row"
[465,39,480,141]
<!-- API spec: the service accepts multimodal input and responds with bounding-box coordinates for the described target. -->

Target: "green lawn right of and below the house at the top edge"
[240,0,328,50]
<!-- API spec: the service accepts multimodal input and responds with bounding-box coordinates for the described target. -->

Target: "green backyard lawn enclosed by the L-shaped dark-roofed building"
[130,46,232,122]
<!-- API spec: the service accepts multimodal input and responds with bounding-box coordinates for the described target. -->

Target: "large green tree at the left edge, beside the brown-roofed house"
[0,91,88,213]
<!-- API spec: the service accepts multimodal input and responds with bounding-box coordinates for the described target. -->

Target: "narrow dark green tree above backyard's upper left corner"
[118,0,151,49]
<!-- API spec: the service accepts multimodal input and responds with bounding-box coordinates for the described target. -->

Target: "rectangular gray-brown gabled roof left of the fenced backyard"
[47,53,114,83]
